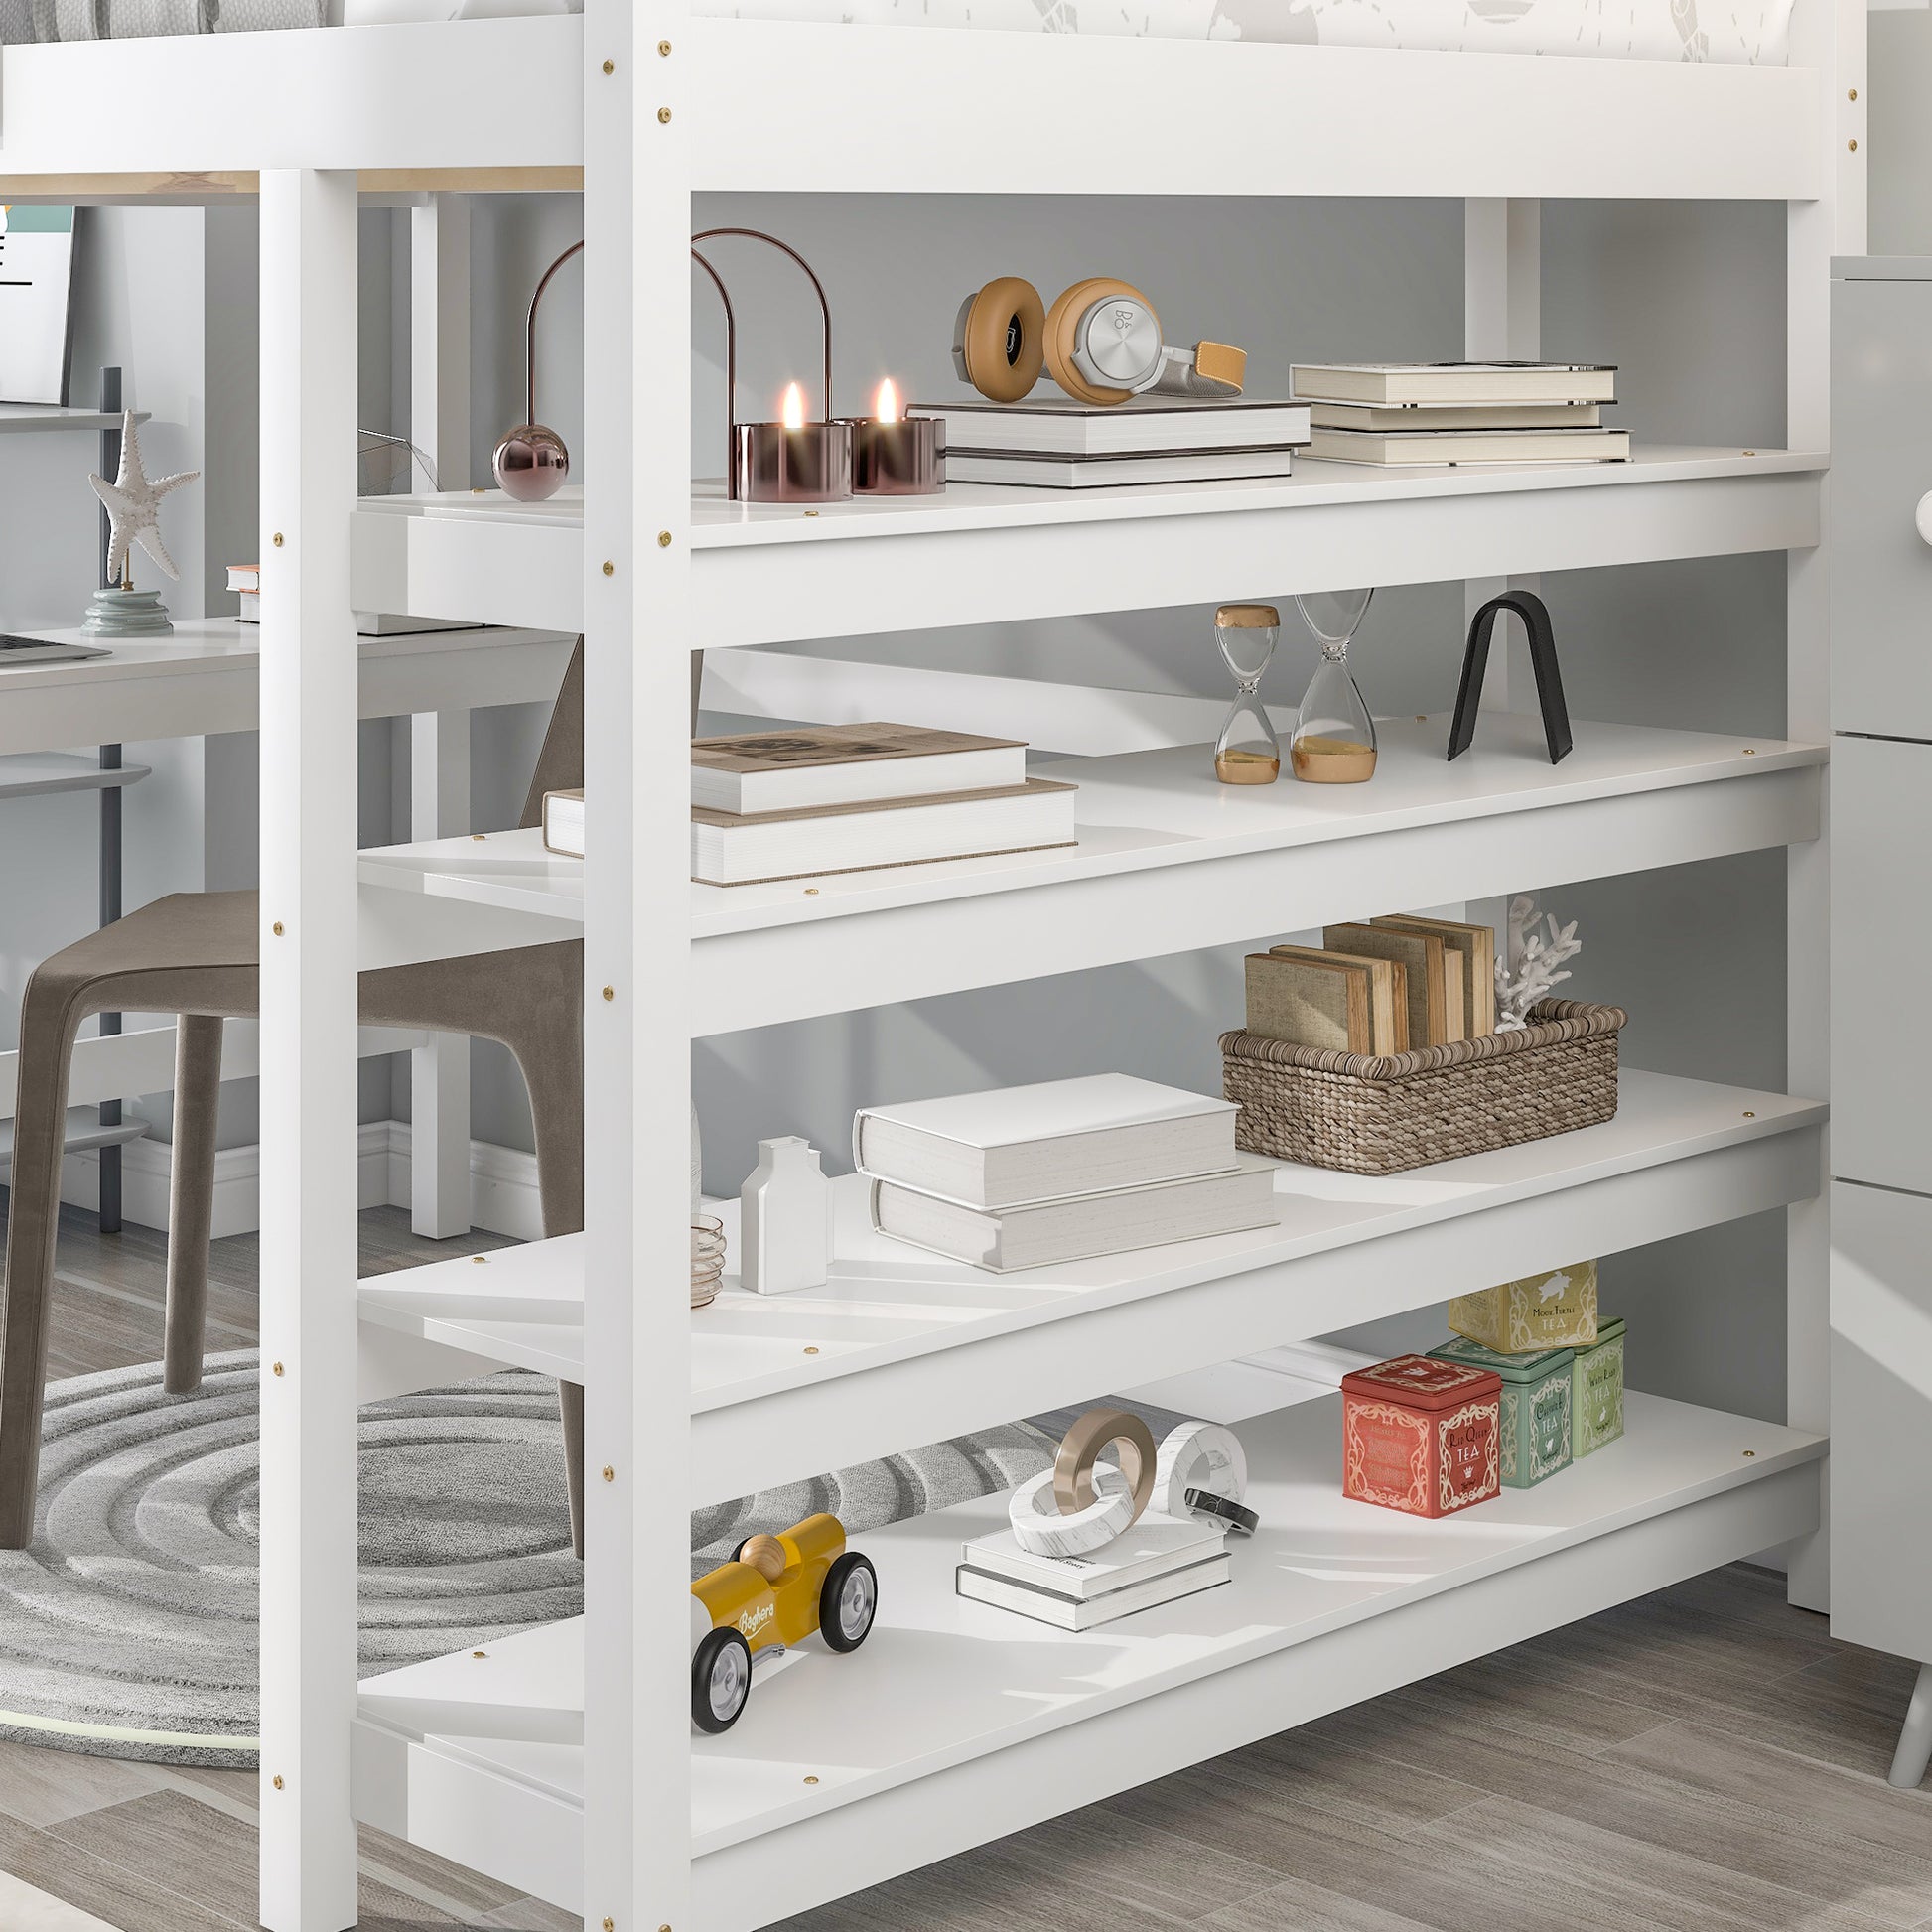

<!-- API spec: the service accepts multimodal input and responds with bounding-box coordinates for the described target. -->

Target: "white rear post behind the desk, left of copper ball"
[400,196,470,1240]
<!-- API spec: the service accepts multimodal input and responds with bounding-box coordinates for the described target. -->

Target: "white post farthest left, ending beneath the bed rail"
[261,168,357,1932]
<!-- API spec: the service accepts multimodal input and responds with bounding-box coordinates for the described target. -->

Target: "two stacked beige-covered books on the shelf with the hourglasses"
[543,725,1078,885]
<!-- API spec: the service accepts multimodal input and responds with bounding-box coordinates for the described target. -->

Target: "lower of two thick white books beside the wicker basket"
[872,1154,1281,1275]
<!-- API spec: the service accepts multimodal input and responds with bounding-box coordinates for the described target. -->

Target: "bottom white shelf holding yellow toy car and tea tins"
[355,1393,1826,1932]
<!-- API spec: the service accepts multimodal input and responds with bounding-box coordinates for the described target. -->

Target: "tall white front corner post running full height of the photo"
[584,0,699,1932]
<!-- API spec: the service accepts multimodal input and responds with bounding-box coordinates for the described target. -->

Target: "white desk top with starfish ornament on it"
[0,625,576,770]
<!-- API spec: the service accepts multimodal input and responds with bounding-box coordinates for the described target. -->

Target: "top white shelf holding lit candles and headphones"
[353,446,1826,649]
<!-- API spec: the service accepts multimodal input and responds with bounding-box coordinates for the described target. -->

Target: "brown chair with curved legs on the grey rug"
[0,639,587,1556]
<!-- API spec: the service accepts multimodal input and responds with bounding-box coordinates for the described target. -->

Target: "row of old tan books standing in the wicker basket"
[1246,913,1495,1053]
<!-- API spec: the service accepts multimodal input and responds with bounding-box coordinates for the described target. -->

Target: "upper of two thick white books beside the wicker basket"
[852,1074,1240,1207]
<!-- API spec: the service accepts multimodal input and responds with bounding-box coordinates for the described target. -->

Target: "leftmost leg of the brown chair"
[0,974,85,1550]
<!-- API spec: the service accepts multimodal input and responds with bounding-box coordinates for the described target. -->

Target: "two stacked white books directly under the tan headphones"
[912,396,1308,488]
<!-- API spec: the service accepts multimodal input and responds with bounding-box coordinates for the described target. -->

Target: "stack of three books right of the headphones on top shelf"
[1289,363,1630,464]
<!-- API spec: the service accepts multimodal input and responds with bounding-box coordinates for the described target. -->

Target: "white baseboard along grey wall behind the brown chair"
[60,1121,543,1240]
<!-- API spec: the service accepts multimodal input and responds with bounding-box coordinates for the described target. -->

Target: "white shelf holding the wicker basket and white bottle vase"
[359,1070,1826,1507]
